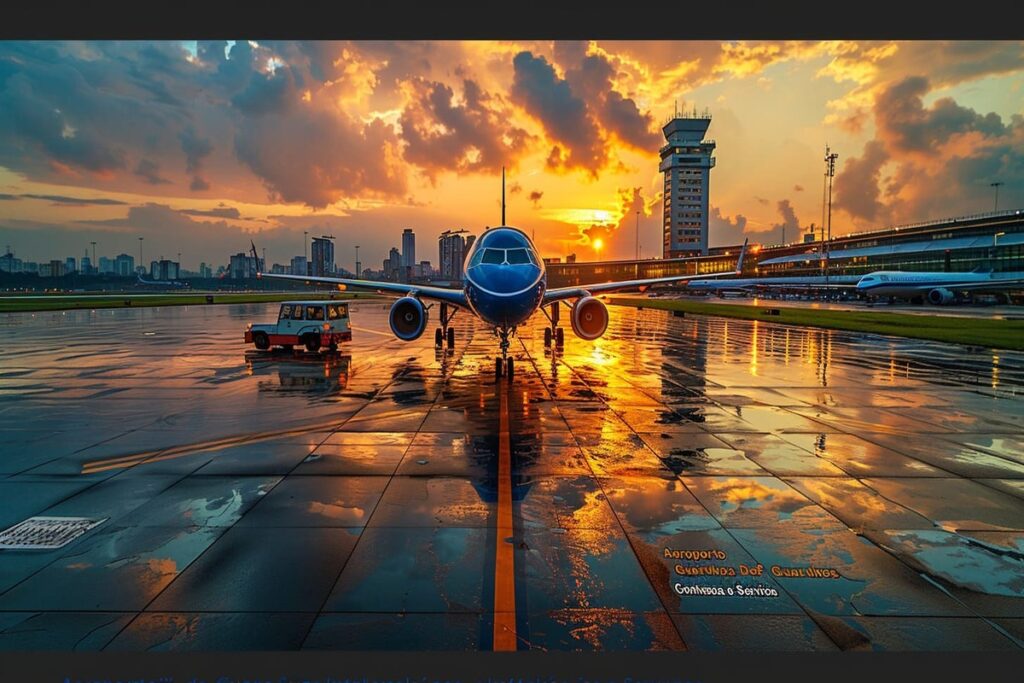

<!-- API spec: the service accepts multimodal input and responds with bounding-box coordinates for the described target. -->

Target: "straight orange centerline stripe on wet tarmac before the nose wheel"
[494,380,516,652]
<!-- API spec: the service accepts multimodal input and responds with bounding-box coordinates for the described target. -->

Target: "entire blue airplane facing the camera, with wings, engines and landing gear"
[250,169,746,382]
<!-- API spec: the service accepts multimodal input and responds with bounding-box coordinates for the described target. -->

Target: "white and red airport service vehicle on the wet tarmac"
[246,301,352,352]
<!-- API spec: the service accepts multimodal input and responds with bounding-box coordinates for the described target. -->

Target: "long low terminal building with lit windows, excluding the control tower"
[547,209,1024,287]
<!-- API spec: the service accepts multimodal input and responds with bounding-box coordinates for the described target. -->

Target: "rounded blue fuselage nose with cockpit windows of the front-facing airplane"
[464,226,547,328]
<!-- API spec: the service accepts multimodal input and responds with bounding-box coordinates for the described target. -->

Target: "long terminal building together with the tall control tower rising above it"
[544,101,1024,287]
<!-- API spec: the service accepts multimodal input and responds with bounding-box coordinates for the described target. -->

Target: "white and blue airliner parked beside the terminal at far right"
[856,269,1024,305]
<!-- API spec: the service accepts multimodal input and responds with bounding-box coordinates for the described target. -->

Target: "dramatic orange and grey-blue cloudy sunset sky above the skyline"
[0,40,1024,269]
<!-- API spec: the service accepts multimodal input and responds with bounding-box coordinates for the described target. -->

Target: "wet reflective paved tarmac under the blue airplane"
[0,302,1024,651]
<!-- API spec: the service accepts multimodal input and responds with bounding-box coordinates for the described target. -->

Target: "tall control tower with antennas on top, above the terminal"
[658,112,715,258]
